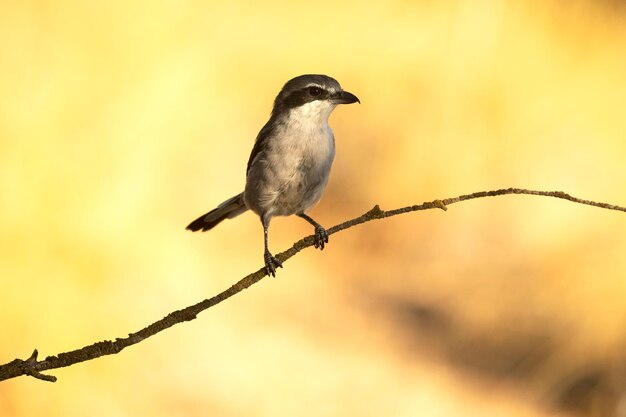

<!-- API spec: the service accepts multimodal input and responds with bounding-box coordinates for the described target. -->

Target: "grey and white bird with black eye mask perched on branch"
[187,74,361,277]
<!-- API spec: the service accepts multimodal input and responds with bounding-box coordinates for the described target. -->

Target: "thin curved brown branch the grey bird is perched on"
[0,188,626,382]
